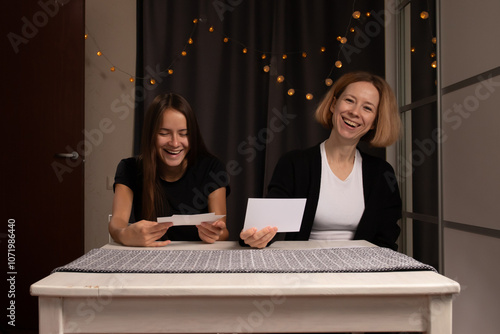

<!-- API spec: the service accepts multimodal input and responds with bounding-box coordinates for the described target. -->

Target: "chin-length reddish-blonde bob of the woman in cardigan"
[315,72,401,147]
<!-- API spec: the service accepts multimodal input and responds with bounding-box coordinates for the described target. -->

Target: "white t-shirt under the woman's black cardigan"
[309,142,365,240]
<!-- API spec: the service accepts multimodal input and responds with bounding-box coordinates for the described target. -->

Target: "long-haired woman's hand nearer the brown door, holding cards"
[117,220,173,247]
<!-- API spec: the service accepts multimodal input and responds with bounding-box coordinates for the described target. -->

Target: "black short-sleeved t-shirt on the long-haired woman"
[115,156,230,241]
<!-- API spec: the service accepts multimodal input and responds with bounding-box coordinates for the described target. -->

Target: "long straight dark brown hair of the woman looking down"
[139,93,210,220]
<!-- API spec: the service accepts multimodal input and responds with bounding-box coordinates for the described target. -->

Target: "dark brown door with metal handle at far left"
[0,0,85,333]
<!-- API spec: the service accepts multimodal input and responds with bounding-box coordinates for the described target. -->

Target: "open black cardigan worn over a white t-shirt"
[266,145,402,250]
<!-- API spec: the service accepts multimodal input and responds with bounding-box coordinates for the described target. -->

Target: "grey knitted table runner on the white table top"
[53,247,436,273]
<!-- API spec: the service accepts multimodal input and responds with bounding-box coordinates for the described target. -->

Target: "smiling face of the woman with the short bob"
[330,81,380,145]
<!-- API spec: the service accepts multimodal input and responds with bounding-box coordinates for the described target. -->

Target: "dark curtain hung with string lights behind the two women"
[135,0,385,240]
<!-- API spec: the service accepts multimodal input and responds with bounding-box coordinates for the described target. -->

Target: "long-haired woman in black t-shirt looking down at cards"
[109,93,230,246]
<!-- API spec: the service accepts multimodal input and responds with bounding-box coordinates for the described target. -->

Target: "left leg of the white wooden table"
[38,297,64,334]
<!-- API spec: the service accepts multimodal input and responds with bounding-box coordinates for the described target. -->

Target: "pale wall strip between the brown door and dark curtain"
[85,0,136,251]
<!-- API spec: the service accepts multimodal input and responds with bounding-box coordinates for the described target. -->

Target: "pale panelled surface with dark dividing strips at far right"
[438,0,500,334]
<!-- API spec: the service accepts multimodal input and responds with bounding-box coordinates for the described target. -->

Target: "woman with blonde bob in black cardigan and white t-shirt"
[240,72,402,249]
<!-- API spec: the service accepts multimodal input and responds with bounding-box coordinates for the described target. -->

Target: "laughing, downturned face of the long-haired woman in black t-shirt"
[156,109,189,172]
